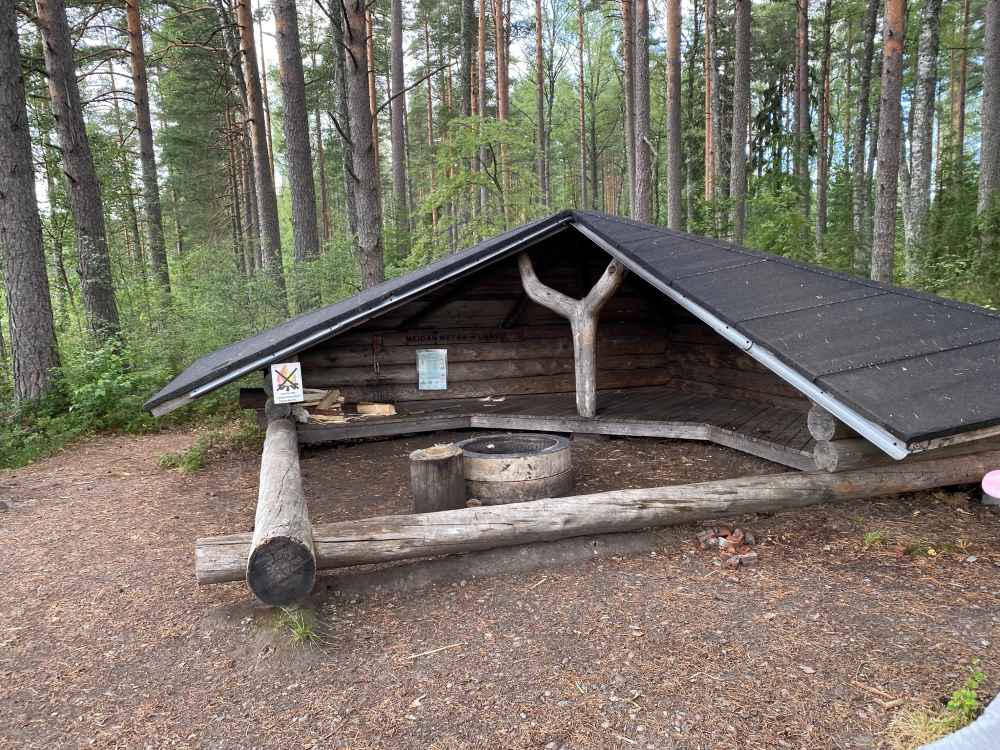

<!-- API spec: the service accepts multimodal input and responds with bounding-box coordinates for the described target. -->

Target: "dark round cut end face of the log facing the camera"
[246,536,316,607]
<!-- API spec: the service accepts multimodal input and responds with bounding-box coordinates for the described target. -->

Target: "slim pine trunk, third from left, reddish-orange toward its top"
[125,0,170,294]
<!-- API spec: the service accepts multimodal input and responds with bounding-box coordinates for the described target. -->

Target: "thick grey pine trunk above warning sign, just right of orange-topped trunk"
[271,0,319,312]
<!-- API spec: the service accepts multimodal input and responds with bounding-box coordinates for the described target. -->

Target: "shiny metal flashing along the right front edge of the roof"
[573,218,910,461]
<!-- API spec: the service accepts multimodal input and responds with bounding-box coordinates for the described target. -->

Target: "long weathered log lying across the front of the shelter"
[195,451,1000,584]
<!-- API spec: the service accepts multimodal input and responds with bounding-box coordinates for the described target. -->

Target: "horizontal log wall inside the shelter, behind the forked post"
[300,240,809,410]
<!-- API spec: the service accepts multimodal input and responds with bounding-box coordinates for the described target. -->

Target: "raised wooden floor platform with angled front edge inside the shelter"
[299,386,815,470]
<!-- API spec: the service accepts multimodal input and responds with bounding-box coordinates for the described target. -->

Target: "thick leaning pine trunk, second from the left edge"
[35,0,119,340]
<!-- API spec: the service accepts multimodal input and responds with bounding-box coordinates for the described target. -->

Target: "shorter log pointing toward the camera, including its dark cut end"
[244,419,316,605]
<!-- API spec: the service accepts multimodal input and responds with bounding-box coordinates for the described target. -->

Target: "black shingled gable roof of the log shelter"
[146,211,1000,450]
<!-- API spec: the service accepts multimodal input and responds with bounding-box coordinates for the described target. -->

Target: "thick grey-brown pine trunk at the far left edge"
[0,0,59,401]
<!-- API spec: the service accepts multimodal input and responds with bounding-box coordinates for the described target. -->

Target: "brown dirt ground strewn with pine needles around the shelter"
[0,431,1000,750]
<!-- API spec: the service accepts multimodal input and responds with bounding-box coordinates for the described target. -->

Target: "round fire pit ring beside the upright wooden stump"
[457,433,573,505]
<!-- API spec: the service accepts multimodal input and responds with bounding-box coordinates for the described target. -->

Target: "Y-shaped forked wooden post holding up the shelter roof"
[517,253,625,417]
